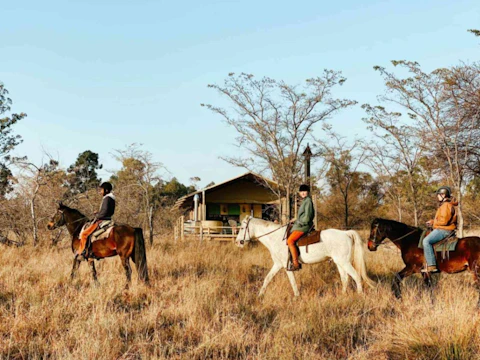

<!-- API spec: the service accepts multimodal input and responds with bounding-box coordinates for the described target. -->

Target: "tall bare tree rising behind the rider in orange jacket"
[375,61,480,236]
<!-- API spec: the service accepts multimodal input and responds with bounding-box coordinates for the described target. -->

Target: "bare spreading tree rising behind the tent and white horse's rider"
[202,70,356,221]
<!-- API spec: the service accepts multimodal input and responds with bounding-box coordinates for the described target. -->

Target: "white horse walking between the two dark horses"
[235,217,374,296]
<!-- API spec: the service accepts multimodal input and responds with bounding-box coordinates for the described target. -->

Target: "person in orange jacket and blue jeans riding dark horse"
[422,186,458,272]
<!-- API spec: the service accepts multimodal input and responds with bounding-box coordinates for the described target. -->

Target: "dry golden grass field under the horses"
[0,233,480,359]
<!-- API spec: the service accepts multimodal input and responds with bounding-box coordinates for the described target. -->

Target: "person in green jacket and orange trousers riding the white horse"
[287,185,315,271]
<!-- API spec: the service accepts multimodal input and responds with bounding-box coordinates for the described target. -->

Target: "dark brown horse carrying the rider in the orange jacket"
[368,219,480,306]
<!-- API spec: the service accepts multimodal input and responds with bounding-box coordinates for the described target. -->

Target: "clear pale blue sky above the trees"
[0,0,480,186]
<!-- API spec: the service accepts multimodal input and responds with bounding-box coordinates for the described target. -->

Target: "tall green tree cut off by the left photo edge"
[0,82,27,196]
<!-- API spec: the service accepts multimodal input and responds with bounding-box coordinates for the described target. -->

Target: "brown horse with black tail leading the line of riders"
[47,203,148,287]
